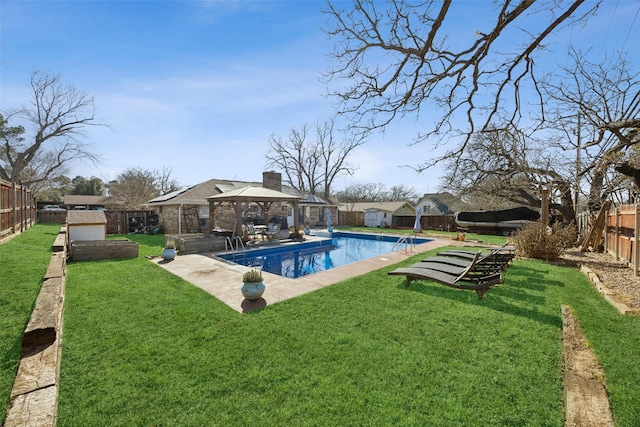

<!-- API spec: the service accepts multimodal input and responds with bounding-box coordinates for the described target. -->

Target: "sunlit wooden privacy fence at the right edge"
[604,204,640,275]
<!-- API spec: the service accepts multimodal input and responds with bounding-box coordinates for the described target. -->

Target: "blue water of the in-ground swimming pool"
[221,232,430,279]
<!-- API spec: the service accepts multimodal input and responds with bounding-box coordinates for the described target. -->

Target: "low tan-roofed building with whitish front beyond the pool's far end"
[338,201,416,228]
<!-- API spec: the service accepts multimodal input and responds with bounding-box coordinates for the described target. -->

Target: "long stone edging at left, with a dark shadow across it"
[4,227,67,427]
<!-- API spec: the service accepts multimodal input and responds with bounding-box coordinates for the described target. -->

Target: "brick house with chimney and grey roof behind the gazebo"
[147,172,336,234]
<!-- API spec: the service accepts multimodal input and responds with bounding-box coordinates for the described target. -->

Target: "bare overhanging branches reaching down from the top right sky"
[326,0,600,170]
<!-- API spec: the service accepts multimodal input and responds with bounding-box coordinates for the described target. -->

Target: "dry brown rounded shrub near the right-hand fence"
[510,222,578,261]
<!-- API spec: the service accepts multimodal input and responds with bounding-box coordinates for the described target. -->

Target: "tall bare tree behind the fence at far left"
[0,72,99,186]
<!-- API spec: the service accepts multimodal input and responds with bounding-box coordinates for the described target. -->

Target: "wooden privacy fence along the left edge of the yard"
[0,179,37,241]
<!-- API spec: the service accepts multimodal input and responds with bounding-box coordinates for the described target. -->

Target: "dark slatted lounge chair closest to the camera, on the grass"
[387,253,503,299]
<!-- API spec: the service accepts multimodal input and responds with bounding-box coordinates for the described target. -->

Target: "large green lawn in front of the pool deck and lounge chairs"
[2,226,640,426]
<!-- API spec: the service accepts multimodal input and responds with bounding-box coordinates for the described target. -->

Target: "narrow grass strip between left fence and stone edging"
[0,224,60,421]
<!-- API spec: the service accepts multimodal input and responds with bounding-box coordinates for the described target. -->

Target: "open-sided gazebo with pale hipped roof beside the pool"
[207,186,300,236]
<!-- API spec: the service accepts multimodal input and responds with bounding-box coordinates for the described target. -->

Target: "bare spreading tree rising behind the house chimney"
[266,120,365,199]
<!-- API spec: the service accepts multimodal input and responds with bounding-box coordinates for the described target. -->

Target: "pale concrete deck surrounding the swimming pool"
[151,238,462,313]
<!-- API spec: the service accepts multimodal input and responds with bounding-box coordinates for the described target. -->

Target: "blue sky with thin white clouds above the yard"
[0,0,640,193]
